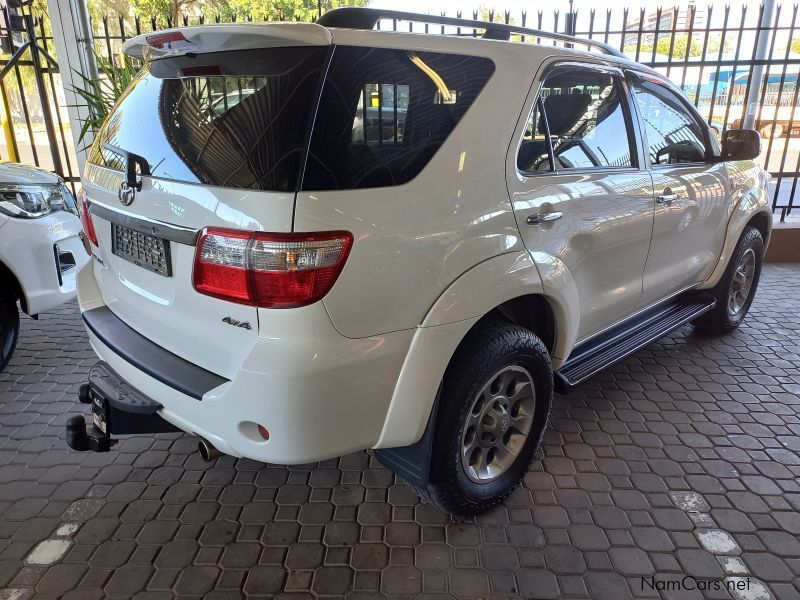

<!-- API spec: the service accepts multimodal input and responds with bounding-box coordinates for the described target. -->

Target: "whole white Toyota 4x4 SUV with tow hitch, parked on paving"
[68,9,772,514]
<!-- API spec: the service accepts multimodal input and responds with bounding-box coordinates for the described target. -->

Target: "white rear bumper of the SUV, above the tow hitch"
[78,260,413,464]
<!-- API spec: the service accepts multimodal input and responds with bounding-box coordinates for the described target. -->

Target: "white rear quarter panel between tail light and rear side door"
[295,35,546,338]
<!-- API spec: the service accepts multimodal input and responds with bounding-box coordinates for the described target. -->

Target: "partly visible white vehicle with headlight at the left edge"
[0,162,87,371]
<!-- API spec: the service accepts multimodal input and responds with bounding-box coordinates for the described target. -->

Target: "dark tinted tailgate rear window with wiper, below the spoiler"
[89,46,329,191]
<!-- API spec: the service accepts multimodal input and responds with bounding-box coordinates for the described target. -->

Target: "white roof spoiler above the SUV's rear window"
[122,23,332,61]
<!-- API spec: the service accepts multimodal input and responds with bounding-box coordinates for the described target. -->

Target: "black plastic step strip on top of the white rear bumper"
[83,306,228,400]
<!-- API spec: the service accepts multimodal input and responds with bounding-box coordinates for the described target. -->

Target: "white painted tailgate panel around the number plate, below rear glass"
[84,165,292,378]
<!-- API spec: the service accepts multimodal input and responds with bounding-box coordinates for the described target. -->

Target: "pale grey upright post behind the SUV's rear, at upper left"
[47,0,97,172]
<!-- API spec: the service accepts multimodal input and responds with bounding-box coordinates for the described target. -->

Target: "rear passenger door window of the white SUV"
[517,67,633,171]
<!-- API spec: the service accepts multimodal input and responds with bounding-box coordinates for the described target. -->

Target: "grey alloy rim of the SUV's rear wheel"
[461,365,536,483]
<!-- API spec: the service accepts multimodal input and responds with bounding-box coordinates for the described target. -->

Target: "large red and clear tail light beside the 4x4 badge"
[192,228,353,308]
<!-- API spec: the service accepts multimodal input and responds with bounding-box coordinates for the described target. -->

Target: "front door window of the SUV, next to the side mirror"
[632,78,706,165]
